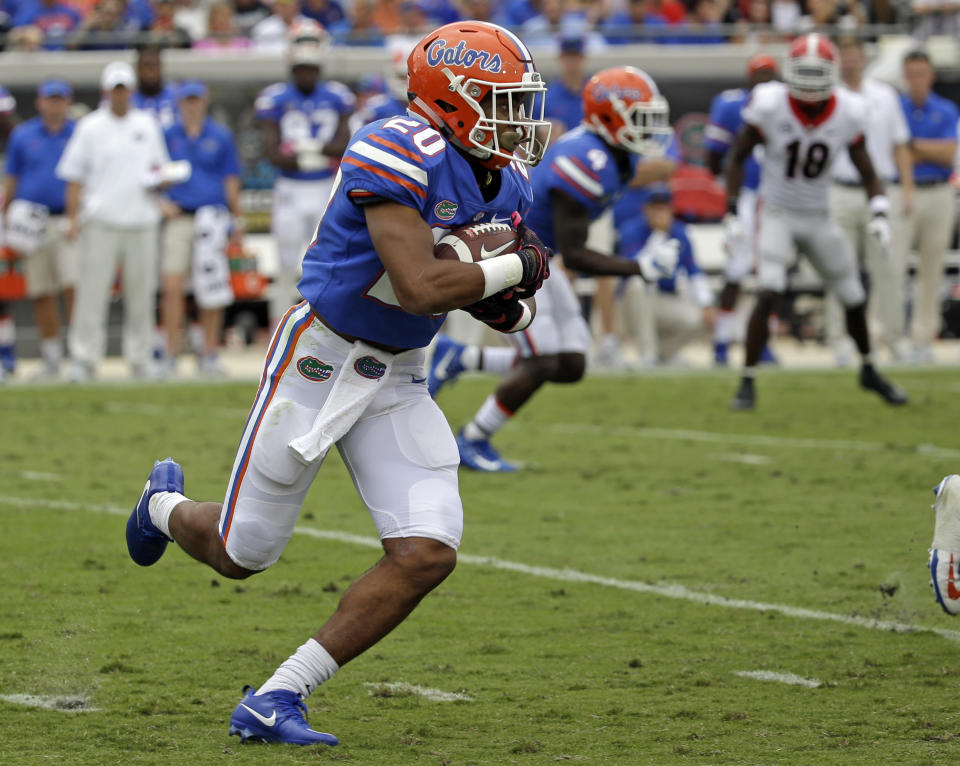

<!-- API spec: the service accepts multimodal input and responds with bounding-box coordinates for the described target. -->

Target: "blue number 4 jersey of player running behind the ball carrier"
[527,125,639,250]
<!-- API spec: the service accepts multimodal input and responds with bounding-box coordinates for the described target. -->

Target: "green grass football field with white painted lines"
[0,370,960,766]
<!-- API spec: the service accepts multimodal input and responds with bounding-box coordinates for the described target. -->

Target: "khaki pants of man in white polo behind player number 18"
[823,184,904,353]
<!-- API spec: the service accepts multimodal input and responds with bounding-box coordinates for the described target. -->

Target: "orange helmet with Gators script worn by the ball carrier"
[407,21,550,169]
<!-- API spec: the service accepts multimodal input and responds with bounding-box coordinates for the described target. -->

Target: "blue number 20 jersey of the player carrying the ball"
[299,117,532,348]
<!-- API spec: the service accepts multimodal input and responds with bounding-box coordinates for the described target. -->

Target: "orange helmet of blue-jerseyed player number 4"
[583,66,673,157]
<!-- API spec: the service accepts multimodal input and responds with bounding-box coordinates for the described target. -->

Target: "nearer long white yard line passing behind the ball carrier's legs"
[0,495,960,643]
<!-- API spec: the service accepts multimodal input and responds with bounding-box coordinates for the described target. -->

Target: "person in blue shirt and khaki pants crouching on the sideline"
[620,184,713,364]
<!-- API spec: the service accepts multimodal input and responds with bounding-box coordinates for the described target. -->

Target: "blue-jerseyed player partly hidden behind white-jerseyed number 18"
[703,53,778,366]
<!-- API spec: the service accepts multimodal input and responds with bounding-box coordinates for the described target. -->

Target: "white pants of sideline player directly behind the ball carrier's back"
[270,177,334,318]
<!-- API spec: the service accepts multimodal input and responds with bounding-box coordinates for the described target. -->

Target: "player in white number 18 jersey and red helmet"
[725,34,907,410]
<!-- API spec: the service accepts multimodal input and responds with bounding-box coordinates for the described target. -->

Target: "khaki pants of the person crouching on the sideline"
[623,277,705,364]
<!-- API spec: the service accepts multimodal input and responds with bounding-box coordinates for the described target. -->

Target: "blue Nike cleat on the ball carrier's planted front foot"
[230,685,340,746]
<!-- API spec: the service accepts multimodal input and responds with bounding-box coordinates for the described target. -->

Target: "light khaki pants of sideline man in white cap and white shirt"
[68,222,159,369]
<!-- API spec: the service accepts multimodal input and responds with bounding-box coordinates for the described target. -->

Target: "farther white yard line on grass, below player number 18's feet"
[540,423,960,459]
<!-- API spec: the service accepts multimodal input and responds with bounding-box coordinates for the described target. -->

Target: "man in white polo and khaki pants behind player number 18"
[824,37,914,365]
